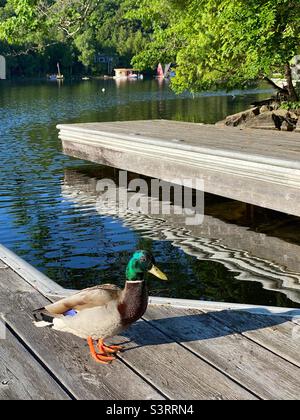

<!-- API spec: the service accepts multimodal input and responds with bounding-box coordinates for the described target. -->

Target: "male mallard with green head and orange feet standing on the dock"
[34,251,167,364]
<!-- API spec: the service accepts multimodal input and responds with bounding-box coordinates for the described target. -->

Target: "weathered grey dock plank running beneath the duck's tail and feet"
[0,270,163,400]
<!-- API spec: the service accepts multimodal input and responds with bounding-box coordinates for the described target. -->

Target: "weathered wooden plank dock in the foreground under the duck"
[0,246,300,400]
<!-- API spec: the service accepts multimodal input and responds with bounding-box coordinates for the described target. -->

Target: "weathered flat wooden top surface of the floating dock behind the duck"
[58,120,300,160]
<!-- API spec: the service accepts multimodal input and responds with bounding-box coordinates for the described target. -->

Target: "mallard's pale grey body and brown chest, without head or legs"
[36,280,148,340]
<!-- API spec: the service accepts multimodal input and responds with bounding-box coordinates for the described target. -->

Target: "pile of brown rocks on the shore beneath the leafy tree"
[216,104,300,133]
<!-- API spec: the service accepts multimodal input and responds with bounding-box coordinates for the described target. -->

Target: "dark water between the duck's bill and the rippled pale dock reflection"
[138,242,299,308]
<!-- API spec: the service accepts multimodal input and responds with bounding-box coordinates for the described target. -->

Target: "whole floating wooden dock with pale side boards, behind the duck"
[58,120,300,216]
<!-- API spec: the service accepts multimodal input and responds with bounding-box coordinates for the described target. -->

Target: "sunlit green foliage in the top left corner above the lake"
[0,0,145,71]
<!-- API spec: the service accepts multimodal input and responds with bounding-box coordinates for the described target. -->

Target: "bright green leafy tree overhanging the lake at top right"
[128,0,300,101]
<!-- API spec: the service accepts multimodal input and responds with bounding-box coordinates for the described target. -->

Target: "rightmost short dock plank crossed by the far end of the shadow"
[207,311,300,368]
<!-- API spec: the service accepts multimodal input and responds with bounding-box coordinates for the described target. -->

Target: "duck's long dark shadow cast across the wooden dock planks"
[120,306,292,352]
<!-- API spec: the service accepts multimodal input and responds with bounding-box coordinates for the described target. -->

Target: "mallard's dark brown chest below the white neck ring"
[118,281,148,326]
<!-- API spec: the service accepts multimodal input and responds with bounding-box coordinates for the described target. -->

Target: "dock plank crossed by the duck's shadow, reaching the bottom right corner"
[146,306,300,400]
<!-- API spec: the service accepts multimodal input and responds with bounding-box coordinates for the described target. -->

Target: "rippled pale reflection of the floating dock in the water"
[62,170,300,303]
